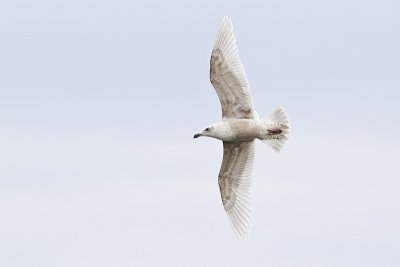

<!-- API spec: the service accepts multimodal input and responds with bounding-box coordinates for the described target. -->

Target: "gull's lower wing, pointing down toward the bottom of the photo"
[218,140,255,239]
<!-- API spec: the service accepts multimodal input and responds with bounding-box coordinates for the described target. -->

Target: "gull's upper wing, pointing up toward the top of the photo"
[210,17,257,119]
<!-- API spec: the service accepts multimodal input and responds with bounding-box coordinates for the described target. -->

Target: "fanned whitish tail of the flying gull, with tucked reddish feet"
[261,108,289,152]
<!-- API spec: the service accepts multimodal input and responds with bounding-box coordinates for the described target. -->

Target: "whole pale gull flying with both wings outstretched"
[194,17,289,239]
